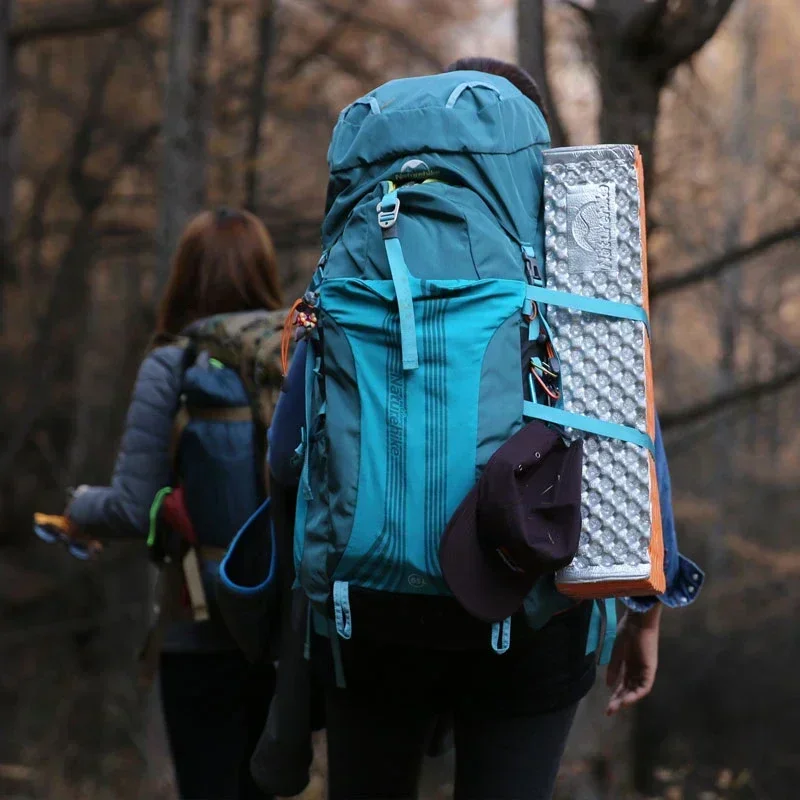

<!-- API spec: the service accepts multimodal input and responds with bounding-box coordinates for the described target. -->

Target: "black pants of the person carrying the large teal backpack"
[314,608,595,800]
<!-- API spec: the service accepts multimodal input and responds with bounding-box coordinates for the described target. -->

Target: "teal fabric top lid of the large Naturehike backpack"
[323,71,550,248]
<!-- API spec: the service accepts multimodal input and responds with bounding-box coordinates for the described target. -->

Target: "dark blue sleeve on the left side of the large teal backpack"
[268,340,307,486]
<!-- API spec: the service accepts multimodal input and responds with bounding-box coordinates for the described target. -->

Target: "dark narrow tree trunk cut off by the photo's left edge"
[0,0,17,331]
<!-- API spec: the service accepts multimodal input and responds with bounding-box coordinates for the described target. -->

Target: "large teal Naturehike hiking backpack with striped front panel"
[294,72,614,668]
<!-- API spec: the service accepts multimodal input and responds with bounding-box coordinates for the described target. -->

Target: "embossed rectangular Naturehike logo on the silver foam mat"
[567,183,617,272]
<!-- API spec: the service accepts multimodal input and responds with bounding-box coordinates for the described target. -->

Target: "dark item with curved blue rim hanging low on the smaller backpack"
[215,500,280,663]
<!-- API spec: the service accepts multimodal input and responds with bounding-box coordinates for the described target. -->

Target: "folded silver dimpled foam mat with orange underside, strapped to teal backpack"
[544,145,665,598]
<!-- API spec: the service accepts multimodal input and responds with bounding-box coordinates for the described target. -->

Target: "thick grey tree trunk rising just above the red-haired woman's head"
[156,0,209,291]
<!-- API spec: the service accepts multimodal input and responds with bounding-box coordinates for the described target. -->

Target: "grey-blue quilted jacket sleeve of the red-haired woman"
[67,345,184,538]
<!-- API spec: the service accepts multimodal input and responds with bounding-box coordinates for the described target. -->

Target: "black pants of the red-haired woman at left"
[160,651,275,800]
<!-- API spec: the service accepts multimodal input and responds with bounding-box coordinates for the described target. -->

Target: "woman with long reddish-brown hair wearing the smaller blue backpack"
[67,208,285,800]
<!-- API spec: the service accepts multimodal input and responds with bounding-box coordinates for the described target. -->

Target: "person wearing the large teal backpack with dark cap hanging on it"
[269,59,702,800]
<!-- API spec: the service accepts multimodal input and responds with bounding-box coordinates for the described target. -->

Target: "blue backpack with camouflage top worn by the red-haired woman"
[150,310,286,650]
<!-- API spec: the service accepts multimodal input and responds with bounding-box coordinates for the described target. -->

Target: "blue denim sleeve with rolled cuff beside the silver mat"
[622,416,705,612]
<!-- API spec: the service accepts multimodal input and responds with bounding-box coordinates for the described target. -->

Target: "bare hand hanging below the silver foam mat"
[606,603,662,716]
